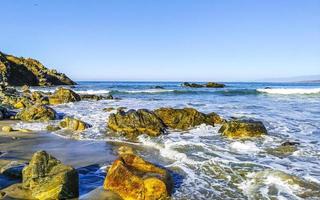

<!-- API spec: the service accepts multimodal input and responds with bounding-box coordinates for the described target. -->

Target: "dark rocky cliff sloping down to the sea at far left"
[0,52,76,86]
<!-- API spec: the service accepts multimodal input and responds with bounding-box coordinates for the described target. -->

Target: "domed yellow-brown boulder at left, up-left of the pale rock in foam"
[16,104,56,121]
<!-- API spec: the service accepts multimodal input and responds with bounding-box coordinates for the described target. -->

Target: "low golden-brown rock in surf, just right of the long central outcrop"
[219,120,267,139]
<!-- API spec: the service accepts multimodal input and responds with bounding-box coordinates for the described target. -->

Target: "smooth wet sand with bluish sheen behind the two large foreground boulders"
[0,121,116,199]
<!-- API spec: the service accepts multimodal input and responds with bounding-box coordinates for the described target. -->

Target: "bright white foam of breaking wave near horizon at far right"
[257,88,320,94]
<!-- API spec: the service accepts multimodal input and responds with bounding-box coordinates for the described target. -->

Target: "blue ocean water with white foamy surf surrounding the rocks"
[17,82,320,199]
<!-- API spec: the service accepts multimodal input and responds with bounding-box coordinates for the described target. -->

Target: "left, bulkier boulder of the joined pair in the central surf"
[108,109,165,137]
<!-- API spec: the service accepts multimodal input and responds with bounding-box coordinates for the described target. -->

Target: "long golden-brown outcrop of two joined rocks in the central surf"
[108,108,224,137]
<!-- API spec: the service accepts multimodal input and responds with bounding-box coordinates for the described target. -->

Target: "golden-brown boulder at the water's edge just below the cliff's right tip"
[49,88,81,105]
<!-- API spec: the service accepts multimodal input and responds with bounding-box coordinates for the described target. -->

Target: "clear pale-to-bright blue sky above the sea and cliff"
[0,0,320,81]
